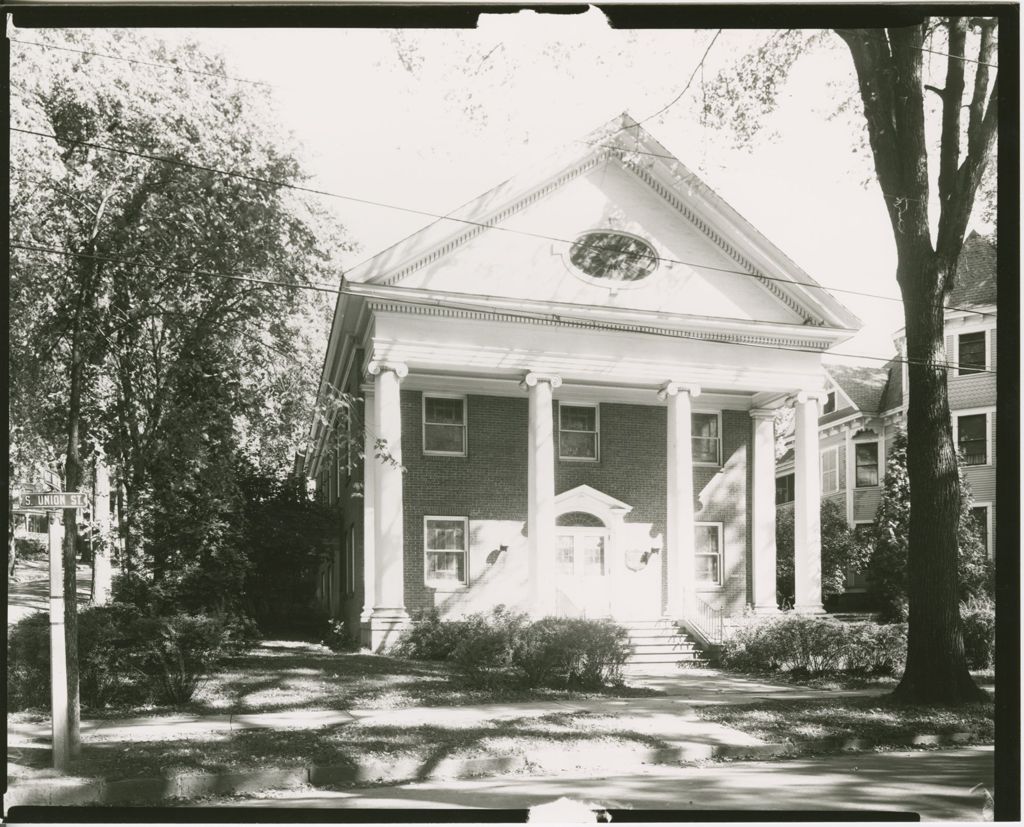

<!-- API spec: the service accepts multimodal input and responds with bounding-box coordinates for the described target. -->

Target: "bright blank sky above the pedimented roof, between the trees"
[34,8,991,363]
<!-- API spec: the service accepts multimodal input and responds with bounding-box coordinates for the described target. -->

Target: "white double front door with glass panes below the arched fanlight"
[555,527,611,617]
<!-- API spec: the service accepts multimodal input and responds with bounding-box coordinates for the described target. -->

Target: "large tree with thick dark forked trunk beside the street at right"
[708,16,998,703]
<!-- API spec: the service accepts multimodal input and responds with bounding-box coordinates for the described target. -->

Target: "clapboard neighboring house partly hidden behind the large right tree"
[776,232,996,608]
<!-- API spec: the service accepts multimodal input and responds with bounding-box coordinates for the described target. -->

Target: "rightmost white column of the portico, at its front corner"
[793,392,824,614]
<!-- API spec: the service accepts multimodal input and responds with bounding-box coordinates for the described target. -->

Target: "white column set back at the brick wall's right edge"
[751,408,778,614]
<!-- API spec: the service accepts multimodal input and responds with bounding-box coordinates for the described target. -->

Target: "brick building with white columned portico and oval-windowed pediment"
[301,115,860,650]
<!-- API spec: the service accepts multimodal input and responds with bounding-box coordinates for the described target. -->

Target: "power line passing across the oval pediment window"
[8,126,987,315]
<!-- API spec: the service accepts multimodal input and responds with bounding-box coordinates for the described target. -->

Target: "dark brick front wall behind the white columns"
[401,391,751,612]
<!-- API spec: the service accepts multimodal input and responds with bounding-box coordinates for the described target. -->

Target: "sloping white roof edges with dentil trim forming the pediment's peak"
[345,114,861,332]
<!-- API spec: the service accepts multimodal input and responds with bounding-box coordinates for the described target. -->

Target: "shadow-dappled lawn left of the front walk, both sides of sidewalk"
[8,641,665,778]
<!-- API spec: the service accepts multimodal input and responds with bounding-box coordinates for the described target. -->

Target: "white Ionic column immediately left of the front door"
[522,373,562,617]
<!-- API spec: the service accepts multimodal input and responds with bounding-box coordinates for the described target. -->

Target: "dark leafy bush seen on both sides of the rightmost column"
[775,499,868,606]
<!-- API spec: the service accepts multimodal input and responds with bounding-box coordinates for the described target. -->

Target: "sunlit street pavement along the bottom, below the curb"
[188,746,994,823]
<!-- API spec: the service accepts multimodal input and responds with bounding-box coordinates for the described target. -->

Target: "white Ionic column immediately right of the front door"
[658,382,700,620]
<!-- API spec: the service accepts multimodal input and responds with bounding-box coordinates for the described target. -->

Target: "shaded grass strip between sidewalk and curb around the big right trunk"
[696,697,994,752]
